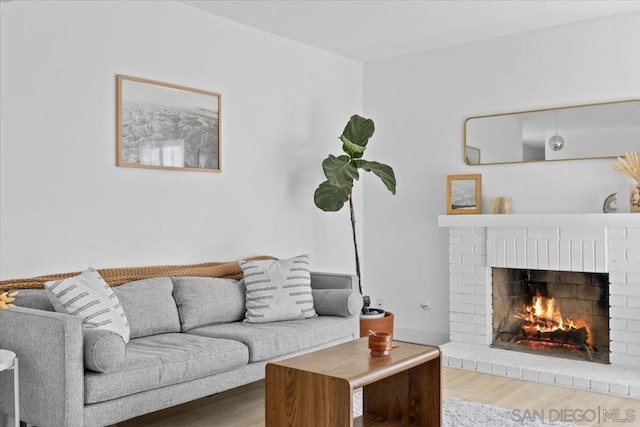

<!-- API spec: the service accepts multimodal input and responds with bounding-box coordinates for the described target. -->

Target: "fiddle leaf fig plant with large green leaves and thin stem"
[313,115,396,310]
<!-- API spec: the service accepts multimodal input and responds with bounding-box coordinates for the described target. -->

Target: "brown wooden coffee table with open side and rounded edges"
[266,337,442,427]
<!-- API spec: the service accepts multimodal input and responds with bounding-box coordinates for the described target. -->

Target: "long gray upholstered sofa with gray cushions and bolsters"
[0,273,362,427]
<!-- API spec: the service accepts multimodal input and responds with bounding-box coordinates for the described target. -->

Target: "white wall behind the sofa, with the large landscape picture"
[0,1,363,279]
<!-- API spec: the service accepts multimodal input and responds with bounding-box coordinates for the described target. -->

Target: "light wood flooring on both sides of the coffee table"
[118,368,640,427]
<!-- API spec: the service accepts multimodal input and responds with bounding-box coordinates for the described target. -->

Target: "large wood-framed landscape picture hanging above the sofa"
[116,74,222,173]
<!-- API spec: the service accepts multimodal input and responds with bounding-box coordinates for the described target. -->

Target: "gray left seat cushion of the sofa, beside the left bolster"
[84,333,249,404]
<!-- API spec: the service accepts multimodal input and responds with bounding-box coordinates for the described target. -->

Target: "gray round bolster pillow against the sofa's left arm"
[82,329,126,372]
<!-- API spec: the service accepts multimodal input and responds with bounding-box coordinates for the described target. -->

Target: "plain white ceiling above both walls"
[182,0,640,62]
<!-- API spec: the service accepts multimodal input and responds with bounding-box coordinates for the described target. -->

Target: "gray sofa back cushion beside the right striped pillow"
[172,277,245,331]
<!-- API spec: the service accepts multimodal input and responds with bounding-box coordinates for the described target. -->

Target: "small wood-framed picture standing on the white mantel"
[447,174,482,215]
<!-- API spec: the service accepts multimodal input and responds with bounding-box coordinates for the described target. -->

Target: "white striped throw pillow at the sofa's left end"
[44,267,130,344]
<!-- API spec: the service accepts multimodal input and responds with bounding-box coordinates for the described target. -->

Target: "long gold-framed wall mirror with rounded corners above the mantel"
[462,99,640,166]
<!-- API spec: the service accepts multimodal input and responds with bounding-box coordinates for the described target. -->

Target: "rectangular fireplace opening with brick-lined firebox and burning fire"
[493,268,609,363]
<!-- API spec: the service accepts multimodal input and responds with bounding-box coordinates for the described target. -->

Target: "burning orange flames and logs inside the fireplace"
[515,295,593,348]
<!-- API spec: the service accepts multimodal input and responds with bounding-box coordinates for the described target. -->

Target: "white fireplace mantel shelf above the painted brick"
[438,213,640,227]
